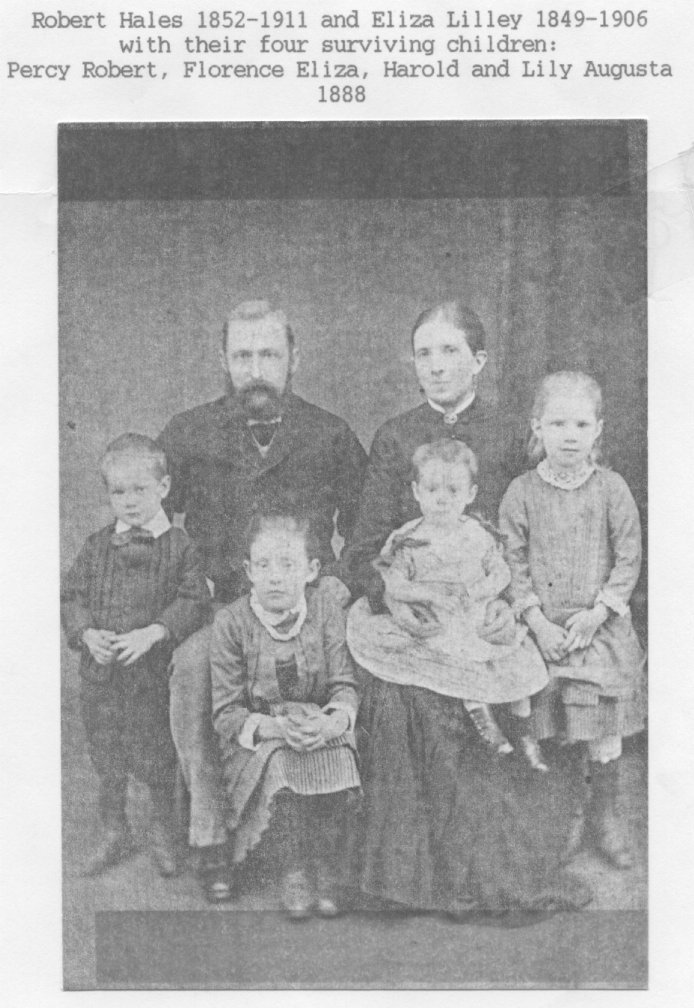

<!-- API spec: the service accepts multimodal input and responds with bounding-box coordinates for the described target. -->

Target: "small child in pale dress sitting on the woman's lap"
[347,438,548,771]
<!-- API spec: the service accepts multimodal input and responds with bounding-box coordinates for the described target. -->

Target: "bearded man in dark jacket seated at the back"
[159,301,366,902]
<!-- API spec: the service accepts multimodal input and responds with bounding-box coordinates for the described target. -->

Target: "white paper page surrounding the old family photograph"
[0,0,694,1006]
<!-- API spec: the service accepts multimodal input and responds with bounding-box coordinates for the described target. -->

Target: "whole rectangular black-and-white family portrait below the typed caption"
[57,119,648,990]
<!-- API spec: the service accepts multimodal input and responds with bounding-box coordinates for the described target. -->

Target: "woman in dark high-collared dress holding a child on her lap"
[344,302,590,921]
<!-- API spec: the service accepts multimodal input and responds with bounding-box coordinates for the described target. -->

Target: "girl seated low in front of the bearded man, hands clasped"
[210,508,360,919]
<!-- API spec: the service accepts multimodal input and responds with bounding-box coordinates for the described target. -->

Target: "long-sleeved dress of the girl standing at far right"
[499,462,645,742]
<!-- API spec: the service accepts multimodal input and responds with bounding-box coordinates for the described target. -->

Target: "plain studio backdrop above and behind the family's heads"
[59,120,647,563]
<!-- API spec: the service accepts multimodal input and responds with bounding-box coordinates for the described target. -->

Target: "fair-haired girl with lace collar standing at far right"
[499,371,645,868]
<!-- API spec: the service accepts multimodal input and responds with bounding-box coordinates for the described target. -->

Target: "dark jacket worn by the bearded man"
[159,392,366,602]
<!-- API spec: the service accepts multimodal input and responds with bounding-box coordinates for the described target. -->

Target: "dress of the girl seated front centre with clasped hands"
[210,578,360,863]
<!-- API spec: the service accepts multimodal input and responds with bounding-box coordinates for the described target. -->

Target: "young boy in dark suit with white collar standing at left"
[61,433,209,876]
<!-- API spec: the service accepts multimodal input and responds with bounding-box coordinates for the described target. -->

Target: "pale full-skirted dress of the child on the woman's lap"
[347,515,547,704]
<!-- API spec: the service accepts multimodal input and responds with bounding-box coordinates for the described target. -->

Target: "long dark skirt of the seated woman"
[360,676,590,913]
